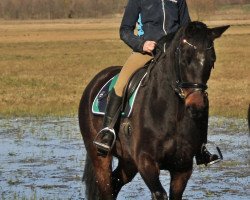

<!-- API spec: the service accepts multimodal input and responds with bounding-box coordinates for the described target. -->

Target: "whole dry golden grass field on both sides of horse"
[0,18,250,117]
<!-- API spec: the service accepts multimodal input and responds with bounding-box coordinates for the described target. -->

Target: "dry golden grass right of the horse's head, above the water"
[209,30,250,117]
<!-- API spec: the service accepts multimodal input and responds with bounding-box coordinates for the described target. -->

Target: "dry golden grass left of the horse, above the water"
[0,20,129,116]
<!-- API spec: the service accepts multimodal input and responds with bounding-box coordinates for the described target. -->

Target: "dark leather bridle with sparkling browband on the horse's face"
[172,39,214,100]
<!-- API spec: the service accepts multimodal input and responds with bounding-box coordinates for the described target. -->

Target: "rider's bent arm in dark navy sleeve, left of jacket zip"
[120,0,145,52]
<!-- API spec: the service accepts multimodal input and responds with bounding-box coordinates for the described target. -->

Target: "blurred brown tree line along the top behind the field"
[0,0,249,19]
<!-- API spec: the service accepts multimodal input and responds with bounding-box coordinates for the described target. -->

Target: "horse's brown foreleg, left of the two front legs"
[138,153,168,200]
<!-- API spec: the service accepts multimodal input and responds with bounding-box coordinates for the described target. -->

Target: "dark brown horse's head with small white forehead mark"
[175,22,229,117]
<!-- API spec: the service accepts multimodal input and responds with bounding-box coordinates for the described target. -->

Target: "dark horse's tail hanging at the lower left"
[82,154,100,200]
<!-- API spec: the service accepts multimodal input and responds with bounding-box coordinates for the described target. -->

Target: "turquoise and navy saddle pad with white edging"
[92,74,145,117]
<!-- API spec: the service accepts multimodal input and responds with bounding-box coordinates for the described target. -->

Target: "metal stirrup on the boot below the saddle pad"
[93,127,116,154]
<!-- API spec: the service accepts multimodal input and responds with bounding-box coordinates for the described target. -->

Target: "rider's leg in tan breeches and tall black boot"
[94,52,153,157]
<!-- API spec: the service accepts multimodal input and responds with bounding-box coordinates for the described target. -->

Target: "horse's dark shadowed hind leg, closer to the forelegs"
[112,159,138,197]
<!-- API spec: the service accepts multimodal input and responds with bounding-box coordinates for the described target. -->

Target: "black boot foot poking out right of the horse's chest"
[195,144,221,166]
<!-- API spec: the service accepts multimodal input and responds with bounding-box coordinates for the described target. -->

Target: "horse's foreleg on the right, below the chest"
[170,169,192,200]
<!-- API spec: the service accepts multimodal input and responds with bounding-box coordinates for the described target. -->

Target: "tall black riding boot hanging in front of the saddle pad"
[94,89,122,157]
